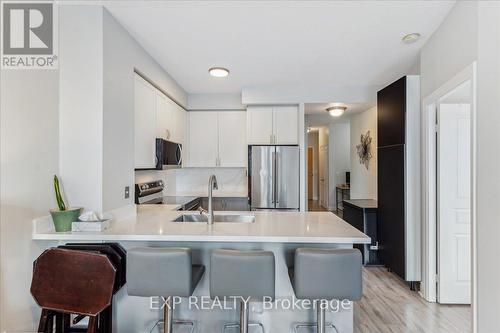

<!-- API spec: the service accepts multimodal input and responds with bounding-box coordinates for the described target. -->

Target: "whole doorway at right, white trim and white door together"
[421,64,476,312]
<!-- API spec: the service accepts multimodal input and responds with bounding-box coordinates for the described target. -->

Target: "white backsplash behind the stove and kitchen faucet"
[135,168,247,195]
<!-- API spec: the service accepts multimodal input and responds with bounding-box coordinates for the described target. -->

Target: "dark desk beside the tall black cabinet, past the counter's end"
[343,199,380,266]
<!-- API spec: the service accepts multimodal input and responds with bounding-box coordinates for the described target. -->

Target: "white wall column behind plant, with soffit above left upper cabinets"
[59,5,187,212]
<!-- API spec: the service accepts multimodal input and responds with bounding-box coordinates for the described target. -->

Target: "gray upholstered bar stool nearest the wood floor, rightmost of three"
[289,248,363,333]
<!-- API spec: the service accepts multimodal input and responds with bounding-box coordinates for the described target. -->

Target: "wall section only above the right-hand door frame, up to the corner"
[420,1,478,97]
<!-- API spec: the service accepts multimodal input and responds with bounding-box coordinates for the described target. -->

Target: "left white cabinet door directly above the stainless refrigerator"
[247,106,273,145]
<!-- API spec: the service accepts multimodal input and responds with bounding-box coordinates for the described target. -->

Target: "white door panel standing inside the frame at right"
[437,104,471,304]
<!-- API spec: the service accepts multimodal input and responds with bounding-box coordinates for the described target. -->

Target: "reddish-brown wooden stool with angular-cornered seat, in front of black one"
[30,248,116,333]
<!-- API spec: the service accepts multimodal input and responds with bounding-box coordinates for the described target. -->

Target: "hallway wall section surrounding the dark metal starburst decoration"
[350,107,377,200]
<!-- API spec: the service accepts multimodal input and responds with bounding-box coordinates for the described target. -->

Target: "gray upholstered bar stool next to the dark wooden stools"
[127,247,205,333]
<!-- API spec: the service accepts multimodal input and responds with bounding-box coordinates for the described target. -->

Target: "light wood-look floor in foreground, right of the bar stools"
[354,267,471,333]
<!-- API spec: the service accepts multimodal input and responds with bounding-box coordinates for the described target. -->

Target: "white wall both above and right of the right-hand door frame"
[421,1,500,333]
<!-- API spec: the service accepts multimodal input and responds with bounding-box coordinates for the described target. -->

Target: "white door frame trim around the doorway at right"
[420,62,477,326]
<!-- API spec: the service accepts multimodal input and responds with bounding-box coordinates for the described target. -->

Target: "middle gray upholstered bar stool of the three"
[210,250,274,333]
